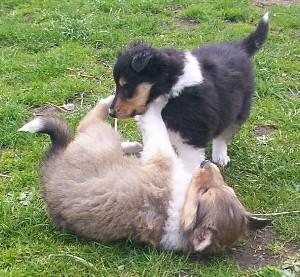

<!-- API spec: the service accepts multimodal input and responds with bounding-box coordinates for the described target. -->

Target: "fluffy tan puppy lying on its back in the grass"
[20,97,268,253]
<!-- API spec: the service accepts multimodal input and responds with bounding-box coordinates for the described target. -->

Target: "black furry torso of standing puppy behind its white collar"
[162,43,254,148]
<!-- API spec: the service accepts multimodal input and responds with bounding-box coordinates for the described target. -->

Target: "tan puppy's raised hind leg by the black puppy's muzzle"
[77,95,114,132]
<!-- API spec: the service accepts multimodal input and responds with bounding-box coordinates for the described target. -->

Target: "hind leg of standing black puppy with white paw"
[212,121,242,166]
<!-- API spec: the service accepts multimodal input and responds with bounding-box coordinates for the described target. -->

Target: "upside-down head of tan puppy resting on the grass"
[181,161,270,254]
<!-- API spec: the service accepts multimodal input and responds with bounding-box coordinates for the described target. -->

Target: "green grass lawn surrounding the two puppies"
[0,0,300,276]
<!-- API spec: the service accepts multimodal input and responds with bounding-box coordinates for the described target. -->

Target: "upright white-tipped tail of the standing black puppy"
[239,12,269,56]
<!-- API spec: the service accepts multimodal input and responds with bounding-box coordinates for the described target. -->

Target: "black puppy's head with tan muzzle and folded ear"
[110,43,180,118]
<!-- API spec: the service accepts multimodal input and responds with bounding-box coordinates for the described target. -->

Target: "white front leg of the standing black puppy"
[168,130,205,173]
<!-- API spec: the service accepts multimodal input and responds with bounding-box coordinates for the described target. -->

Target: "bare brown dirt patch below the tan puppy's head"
[229,229,300,269]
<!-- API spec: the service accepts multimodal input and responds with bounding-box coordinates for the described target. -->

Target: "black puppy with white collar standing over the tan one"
[110,13,269,171]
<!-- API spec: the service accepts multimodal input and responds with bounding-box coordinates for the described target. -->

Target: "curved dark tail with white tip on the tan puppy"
[18,116,72,155]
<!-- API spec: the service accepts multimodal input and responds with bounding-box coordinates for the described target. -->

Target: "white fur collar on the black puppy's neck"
[170,51,203,98]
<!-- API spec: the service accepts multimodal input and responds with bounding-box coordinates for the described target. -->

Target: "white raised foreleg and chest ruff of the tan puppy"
[138,99,192,250]
